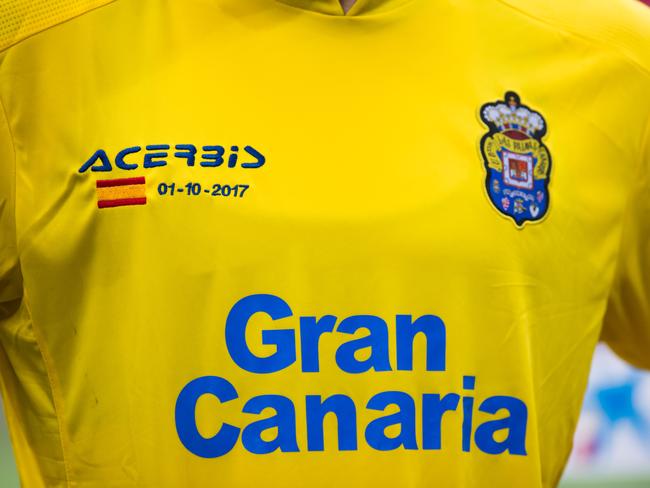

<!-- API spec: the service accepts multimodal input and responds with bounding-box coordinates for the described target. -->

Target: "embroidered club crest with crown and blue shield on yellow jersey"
[480,91,551,228]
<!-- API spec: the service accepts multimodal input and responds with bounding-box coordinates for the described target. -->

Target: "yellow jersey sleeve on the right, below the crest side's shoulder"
[601,114,650,369]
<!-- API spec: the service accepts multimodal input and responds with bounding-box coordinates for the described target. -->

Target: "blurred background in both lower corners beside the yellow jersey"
[0,345,650,488]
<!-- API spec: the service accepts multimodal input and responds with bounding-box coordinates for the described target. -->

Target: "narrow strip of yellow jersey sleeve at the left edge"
[0,96,22,320]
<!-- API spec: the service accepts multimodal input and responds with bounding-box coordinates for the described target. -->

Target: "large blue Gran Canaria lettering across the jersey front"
[175,294,528,458]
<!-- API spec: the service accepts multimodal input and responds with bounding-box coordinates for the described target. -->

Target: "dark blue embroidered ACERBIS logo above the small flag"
[79,144,266,173]
